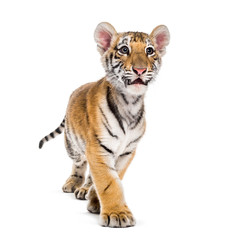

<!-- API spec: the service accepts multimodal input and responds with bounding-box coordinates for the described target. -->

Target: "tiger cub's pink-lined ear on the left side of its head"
[94,22,117,55]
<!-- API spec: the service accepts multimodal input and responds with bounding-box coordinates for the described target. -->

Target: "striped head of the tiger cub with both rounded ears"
[94,22,170,95]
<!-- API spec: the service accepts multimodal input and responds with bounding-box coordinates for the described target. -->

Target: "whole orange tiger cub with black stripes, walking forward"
[39,22,170,227]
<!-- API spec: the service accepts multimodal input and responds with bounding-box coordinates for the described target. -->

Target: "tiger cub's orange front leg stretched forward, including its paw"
[87,144,135,227]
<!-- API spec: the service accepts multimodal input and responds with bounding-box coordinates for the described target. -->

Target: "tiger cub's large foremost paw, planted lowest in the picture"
[100,208,136,228]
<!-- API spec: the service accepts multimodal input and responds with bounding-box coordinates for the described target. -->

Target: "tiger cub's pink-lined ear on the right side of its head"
[150,25,170,57]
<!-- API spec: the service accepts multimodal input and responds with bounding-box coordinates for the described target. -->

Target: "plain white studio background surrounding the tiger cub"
[0,0,237,240]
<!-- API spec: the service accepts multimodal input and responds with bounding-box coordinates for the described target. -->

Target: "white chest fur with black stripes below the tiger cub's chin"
[100,92,145,158]
